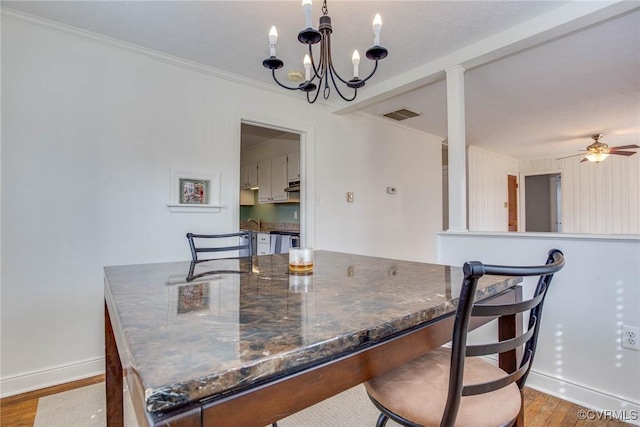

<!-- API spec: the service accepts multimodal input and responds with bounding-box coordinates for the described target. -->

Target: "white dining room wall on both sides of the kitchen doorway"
[0,12,442,396]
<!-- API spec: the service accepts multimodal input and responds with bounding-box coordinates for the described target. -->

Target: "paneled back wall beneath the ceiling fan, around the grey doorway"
[519,155,640,234]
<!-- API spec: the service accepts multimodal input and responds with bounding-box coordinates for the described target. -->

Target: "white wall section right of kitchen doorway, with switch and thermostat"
[316,113,442,261]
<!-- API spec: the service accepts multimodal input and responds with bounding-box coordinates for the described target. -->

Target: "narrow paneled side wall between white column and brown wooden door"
[467,147,518,231]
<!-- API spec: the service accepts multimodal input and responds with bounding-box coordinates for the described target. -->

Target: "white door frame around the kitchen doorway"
[230,111,316,247]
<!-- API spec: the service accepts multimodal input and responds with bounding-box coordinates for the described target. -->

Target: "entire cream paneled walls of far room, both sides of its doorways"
[467,147,640,234]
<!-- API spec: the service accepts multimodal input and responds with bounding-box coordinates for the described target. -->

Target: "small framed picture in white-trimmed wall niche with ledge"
[167,169,221,212]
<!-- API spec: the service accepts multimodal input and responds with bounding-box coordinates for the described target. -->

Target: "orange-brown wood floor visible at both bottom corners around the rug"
[0,375,629,427]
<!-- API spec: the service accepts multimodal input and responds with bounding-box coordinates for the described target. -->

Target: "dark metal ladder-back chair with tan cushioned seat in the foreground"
[365,249,564,427]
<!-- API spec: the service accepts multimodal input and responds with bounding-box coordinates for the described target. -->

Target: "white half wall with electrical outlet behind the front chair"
[437,232,640,423]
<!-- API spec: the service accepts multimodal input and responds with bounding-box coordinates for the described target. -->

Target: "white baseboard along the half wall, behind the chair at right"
[527,370,640,426]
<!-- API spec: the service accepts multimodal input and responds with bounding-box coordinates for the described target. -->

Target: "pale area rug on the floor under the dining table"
[34,383,398,427]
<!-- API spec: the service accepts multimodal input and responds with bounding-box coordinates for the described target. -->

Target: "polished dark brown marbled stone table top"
[105,251,520,412]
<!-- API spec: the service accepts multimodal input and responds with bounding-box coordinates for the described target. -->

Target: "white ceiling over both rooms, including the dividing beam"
[2,0,640,159]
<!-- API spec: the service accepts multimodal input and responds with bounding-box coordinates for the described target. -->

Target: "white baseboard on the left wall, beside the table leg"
[0,357,105,398]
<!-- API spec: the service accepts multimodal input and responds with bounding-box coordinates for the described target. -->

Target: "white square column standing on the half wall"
[445,65,468,231]
